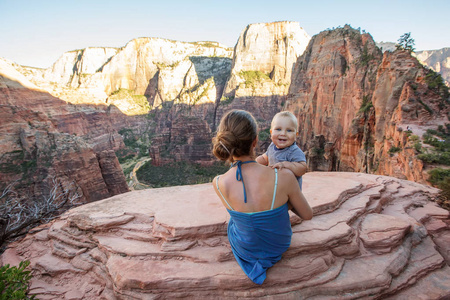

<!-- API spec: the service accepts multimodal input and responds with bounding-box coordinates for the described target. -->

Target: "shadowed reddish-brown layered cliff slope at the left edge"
[0,60,128,202]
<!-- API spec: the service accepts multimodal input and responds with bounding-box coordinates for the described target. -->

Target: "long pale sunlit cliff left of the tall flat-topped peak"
[21,38,232,115]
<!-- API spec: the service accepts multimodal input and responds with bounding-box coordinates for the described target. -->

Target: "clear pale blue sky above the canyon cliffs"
[0,0,450,68]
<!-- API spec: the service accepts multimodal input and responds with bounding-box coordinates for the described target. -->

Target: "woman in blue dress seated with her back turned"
[213,110,312,284]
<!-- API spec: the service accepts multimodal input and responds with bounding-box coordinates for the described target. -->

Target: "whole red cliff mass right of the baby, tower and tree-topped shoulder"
[286,26,448,182]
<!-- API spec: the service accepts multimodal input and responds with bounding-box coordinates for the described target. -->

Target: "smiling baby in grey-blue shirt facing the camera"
[256,111,306,189]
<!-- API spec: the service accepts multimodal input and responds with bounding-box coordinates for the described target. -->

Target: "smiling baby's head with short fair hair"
[270,111,298,149]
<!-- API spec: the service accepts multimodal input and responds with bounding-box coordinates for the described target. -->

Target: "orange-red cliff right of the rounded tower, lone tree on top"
[372,51,449,182]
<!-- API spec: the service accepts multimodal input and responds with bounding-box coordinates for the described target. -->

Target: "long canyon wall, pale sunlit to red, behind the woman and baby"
[5,22,448,188]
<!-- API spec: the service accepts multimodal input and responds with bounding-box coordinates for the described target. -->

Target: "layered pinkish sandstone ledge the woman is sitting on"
[1,172,450,299]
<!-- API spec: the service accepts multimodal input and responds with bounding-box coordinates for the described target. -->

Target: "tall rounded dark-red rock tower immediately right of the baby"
[286,26,382,171]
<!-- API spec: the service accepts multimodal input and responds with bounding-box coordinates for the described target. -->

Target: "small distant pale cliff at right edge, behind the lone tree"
[415,48,450,85]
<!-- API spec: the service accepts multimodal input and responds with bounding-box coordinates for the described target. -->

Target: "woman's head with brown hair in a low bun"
[213,110,258,162]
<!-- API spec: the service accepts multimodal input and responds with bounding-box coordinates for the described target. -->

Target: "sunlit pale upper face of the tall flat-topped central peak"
[224,22,311,97]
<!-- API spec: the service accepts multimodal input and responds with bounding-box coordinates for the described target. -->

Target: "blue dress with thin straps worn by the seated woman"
[216,165,292,284]
